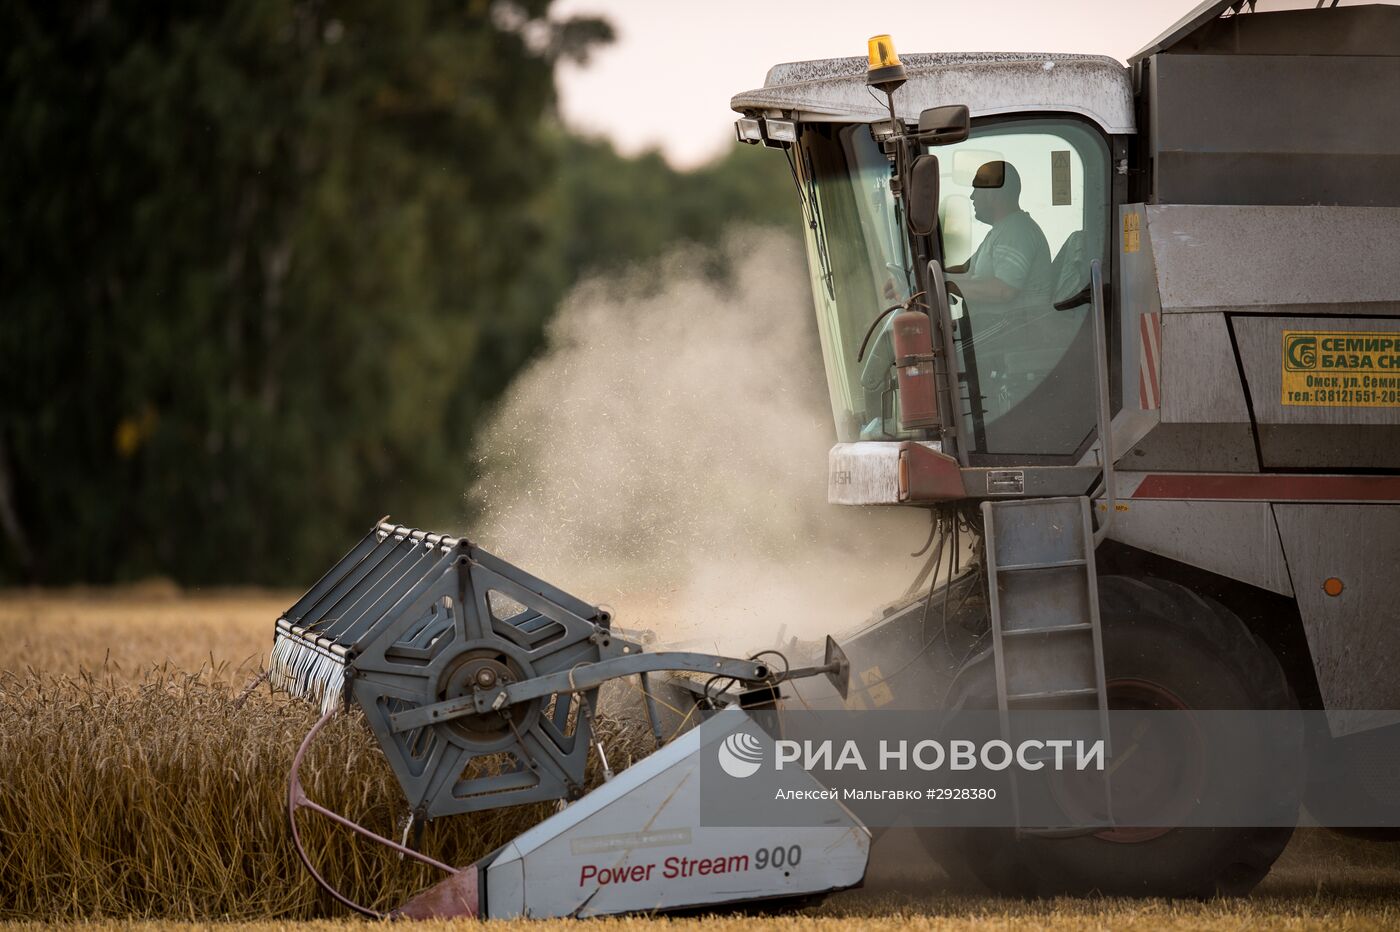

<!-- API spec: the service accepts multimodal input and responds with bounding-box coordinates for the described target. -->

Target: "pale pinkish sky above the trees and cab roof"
[552,0,1366,168]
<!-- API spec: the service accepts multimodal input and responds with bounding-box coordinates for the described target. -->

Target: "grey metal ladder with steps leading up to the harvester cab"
[981,495,1113,820]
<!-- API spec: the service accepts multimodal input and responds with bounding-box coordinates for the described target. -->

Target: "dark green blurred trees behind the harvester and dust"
[0,0,788,584]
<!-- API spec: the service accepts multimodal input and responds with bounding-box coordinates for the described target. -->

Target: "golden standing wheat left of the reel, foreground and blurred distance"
[0,593,652,919]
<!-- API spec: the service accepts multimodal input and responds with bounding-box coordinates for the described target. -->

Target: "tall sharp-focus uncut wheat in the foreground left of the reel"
[0,672,585,918]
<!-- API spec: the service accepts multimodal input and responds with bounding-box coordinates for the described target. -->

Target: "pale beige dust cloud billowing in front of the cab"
[468,232,928,654]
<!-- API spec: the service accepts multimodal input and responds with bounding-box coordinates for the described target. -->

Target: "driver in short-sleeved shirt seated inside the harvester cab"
[948,161,1051,315]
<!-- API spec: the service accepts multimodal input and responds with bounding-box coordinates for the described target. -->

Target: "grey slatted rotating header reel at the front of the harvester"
[272,523,640,819]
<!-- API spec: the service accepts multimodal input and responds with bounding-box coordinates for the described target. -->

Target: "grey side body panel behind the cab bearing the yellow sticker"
[1114,204,1400,472]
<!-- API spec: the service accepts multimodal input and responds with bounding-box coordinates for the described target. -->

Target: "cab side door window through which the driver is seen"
[932,119,1110,462]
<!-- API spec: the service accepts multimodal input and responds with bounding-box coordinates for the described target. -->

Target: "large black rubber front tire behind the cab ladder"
[925,577,1302,897]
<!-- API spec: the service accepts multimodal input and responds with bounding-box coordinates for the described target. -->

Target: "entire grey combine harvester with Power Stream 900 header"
[273,0,1400,917]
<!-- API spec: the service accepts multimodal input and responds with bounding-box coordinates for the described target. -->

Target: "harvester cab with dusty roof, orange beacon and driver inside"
[734,36,1134,505]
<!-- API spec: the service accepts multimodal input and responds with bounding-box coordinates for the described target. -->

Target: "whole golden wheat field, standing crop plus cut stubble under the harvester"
[0,584,1400,932]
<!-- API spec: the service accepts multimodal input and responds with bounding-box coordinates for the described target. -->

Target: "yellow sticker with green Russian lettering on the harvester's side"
[1281,330,1400,407]
